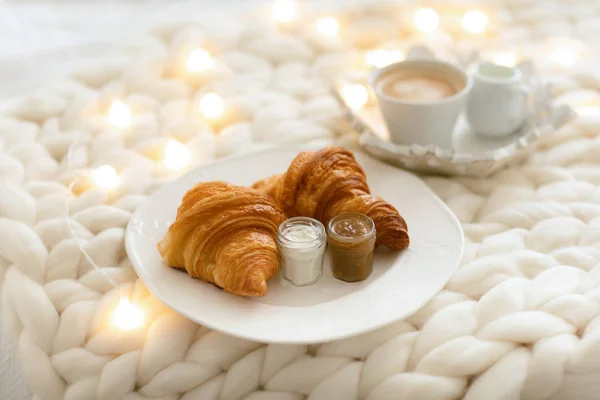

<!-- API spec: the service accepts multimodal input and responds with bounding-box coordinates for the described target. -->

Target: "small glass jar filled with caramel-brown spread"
[327,213,375,282]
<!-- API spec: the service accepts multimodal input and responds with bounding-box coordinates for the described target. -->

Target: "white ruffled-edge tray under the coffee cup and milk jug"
[332,50,575,177]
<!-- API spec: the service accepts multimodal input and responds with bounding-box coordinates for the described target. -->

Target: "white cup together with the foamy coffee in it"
[369,58,471,148]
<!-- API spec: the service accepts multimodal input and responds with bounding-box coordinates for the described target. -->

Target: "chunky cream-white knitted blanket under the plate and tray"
[0,1,600,400]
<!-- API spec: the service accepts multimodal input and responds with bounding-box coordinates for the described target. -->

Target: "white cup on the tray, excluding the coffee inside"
[369,57,471,148]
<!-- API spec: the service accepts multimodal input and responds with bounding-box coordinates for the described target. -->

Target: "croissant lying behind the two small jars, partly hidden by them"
[252,147,409,250]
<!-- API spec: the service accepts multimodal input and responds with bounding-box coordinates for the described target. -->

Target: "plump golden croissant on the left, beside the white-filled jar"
[158,182,285,296]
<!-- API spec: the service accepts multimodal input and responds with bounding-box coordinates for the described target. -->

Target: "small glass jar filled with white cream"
[277,217,327,286]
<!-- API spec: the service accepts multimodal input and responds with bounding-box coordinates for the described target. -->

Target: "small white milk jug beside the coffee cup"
[465,62,530,137]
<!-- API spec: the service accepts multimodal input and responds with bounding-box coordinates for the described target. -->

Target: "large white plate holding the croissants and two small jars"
[126,149,463,343]
